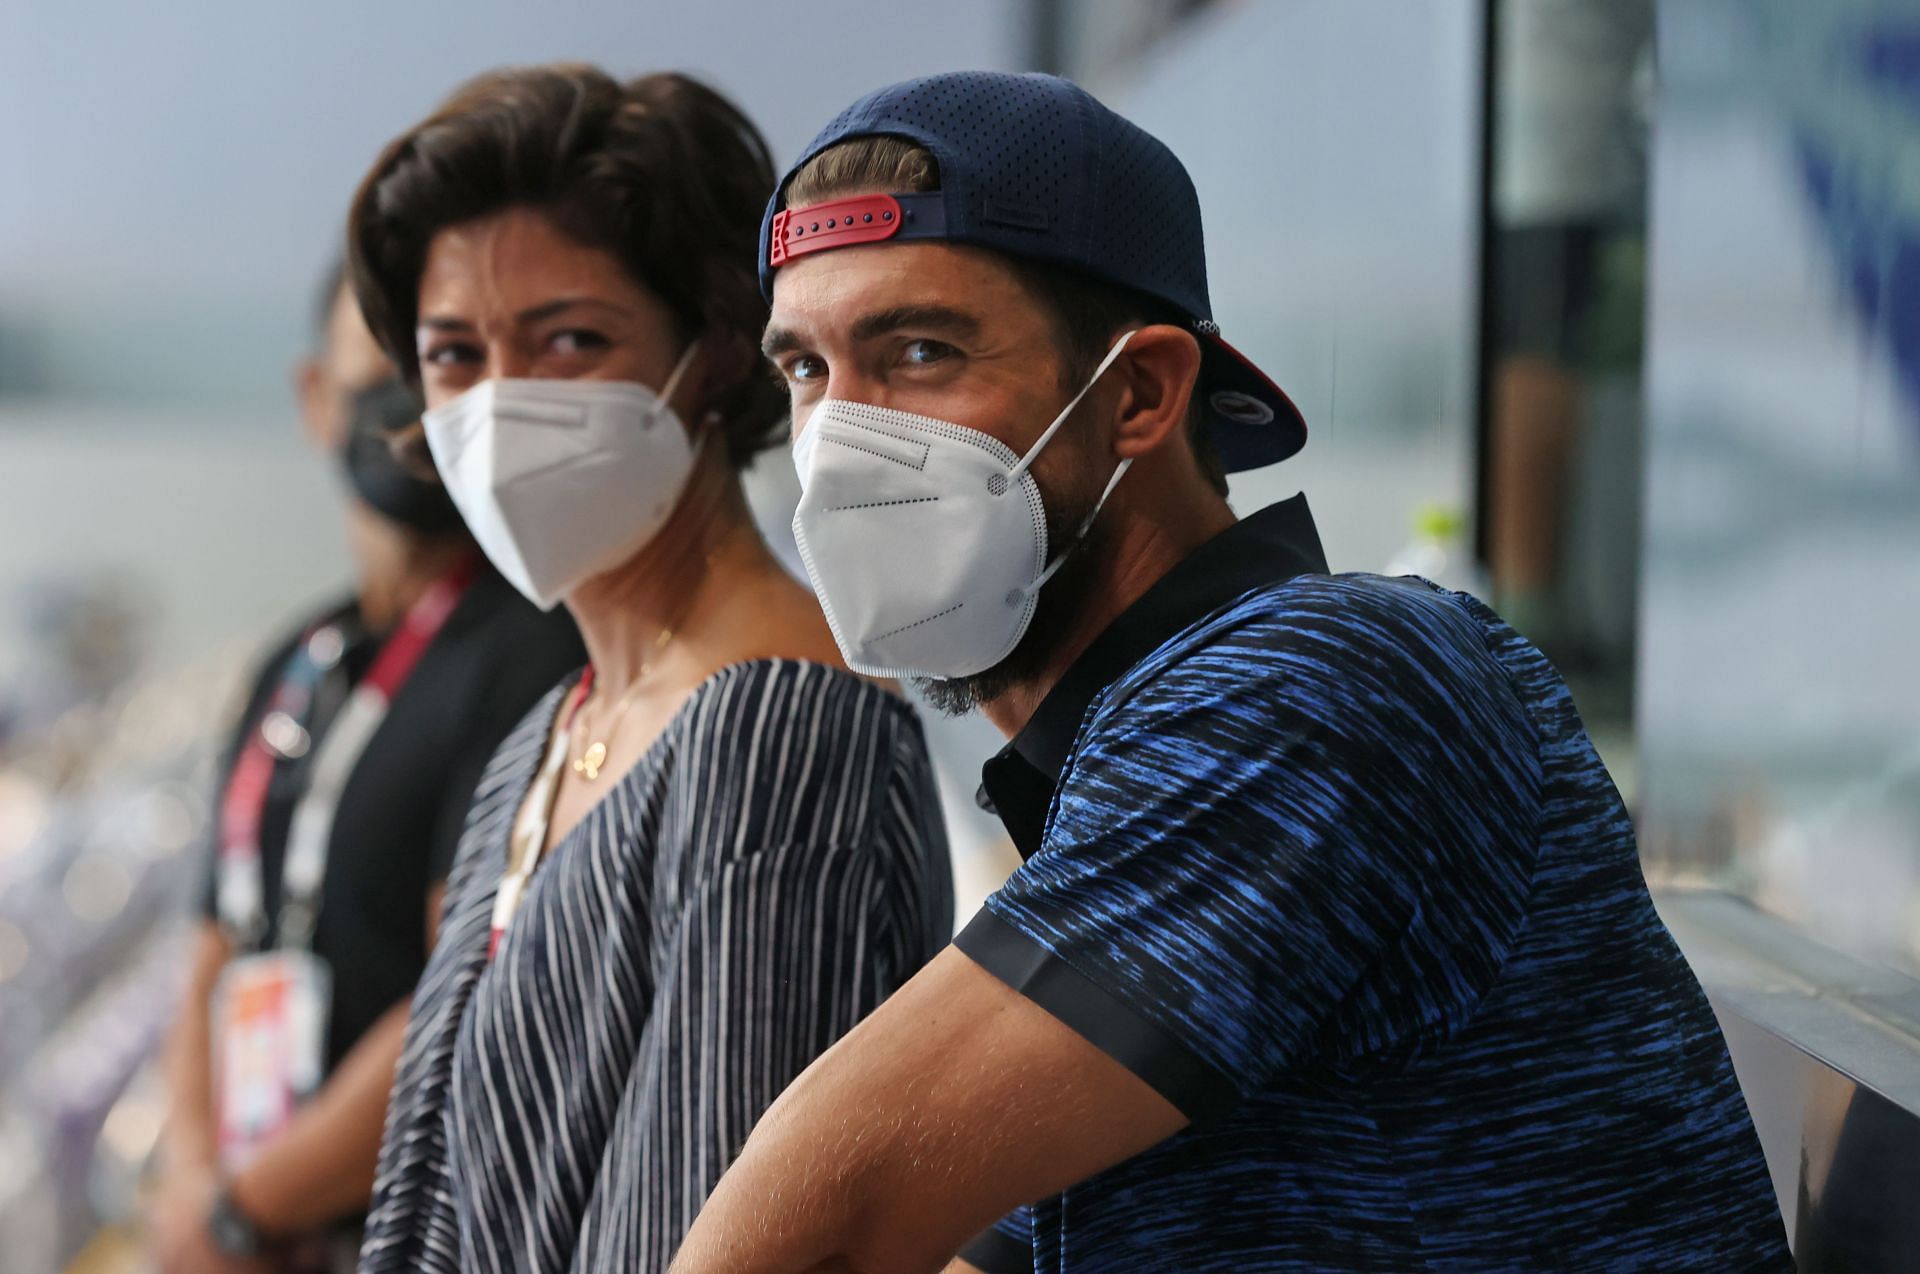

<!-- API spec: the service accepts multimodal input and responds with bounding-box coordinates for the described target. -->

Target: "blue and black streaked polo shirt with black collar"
[956,497,1791,1274]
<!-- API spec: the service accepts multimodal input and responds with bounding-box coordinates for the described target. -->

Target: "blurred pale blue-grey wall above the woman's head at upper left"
[0,0,1021,409]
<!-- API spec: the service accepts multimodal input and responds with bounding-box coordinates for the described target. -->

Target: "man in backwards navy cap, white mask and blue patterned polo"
[676,73,1789,1274]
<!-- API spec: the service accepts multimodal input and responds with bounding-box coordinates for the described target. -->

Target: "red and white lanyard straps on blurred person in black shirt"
[221,558,474,950]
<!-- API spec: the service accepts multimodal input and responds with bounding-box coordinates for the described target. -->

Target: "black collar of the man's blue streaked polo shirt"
[981,495,1327,856]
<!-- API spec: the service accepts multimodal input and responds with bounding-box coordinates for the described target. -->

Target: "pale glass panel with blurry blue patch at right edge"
[1640,0,1920,967]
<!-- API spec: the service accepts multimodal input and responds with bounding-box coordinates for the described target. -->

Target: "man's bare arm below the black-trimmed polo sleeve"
[672,948,1187,1274]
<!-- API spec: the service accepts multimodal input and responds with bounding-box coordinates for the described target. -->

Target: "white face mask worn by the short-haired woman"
[420,345,695,610]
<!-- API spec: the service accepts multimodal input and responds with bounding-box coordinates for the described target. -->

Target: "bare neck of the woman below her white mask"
[566,447,768,695]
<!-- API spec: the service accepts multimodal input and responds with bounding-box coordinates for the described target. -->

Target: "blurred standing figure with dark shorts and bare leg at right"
[1488,0,1653,640]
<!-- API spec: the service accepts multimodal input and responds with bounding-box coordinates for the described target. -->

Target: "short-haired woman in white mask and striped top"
[349,65,952,1270]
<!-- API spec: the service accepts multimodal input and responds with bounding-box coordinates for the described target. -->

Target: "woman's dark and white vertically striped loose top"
[361,660,952,1272]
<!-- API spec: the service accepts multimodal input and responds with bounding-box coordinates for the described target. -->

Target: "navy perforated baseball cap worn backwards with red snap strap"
[760,71,1308,472]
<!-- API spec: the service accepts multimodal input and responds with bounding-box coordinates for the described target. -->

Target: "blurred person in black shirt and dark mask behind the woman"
[150,267,584,1274]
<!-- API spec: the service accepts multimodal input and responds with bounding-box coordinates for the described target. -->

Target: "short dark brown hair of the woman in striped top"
[348,63,787,466]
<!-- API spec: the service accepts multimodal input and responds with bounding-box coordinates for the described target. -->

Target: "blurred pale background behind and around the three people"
[0,0,1920,1274]
